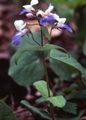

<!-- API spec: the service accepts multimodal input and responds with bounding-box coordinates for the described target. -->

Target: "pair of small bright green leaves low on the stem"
[34,81,66,108]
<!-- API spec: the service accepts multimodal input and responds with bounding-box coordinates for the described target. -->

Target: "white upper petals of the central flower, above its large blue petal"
[36,4,54,16]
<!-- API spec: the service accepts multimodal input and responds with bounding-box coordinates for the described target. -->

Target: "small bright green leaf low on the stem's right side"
[47,96,66,108]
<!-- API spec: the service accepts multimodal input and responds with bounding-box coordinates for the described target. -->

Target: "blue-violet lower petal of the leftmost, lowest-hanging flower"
[12,32,22,46]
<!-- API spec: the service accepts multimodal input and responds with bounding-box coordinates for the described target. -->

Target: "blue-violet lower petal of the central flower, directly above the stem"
[40,16,55,26]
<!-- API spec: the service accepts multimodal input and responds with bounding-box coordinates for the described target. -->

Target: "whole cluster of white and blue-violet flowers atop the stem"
[12,0,72,45]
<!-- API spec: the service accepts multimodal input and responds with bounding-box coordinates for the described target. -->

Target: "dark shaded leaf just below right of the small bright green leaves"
[63,102,77,115]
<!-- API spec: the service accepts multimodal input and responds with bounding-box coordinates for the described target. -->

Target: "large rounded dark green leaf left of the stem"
[9,51,44,86]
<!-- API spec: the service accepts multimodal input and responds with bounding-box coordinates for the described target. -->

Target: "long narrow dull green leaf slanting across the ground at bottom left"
[21,100,51,120]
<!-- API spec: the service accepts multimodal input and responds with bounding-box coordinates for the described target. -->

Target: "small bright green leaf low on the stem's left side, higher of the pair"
[33,80,53,98]
